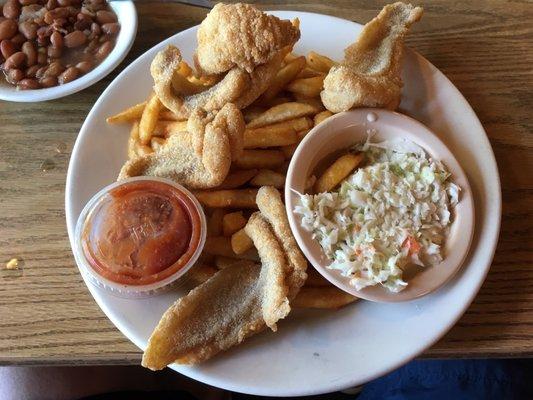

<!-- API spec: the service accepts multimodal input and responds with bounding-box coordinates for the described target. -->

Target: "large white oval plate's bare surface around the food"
[65,11,501,396]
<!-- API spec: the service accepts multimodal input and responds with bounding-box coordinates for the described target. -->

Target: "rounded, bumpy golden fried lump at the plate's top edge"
[195,3,300,75]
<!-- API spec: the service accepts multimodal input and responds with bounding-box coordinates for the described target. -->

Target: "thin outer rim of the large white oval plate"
[65,10,501,397]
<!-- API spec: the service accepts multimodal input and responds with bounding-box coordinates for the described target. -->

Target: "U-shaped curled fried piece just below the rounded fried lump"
[150,46,250,119]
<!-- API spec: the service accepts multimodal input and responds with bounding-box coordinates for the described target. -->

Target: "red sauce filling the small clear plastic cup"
[82,180,201,285]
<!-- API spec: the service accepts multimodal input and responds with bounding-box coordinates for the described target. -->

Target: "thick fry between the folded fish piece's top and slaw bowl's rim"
[244,117,312,149]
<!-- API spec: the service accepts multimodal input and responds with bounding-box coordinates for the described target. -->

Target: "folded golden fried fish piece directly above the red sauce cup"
[118,104,244,189]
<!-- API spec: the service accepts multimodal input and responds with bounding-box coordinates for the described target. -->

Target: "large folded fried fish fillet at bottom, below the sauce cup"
[142,187,307,370]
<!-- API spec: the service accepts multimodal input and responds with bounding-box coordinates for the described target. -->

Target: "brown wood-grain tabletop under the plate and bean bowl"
[0,0,533,365]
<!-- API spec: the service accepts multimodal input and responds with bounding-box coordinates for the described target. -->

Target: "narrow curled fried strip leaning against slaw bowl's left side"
[256,186,307,300]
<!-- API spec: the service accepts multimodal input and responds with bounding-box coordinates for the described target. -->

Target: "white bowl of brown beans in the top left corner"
[0,0,137,102]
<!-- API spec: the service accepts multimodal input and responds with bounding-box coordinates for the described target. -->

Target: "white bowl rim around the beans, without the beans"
[0,0,137,103]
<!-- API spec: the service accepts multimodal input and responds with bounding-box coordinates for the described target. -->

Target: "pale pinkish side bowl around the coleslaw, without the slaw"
[285,109,474,302]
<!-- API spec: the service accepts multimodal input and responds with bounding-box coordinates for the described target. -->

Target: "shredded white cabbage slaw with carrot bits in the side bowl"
[294,137,460,292]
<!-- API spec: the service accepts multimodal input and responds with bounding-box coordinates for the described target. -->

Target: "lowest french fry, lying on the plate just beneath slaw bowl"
[291,286,357,309]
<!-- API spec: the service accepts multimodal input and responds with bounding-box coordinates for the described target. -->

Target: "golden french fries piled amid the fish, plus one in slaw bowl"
[107,51,360,308]
